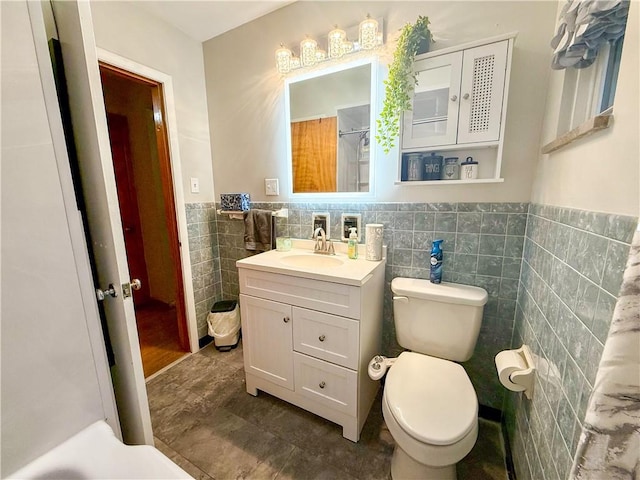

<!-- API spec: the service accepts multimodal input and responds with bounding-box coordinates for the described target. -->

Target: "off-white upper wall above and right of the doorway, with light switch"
[91,1,214,203]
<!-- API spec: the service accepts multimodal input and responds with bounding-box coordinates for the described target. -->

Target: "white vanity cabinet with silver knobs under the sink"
[237,253,384,442]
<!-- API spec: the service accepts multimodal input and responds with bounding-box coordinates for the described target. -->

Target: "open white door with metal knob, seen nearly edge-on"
[52,0,153,445]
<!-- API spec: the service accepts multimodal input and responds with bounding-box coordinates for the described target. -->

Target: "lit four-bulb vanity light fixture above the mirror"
[275,15,383,75]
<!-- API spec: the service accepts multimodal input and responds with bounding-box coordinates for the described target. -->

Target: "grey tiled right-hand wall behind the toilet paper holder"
[505,204,637,480]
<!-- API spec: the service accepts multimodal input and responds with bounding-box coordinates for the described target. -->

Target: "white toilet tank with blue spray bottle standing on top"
[391,278,488,362]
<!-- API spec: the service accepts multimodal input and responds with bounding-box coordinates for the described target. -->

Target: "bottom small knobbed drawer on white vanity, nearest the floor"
[293,352,358,415]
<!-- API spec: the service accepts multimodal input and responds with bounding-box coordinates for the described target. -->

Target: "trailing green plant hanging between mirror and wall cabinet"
[376,16,433,153]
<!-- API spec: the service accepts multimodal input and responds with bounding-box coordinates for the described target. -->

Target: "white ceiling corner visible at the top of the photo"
[134,0,295,42]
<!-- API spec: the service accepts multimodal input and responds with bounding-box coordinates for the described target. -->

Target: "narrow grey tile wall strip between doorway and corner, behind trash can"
[185,203,222,338]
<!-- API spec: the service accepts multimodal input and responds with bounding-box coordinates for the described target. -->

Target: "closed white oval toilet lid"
[384,352,478,445]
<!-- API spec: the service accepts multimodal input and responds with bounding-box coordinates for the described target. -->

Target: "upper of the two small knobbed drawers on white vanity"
[293,307,359,370]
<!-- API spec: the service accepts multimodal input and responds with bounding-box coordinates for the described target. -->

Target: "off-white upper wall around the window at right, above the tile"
[532,1,640,216]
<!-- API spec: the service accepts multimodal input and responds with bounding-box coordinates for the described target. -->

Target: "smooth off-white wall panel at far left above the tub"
[0,2,114,478]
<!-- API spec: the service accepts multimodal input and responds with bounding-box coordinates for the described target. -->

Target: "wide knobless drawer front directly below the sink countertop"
[238,268,360,319]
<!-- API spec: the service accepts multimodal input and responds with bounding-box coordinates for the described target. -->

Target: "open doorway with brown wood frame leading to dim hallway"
[100,62,189,377]
